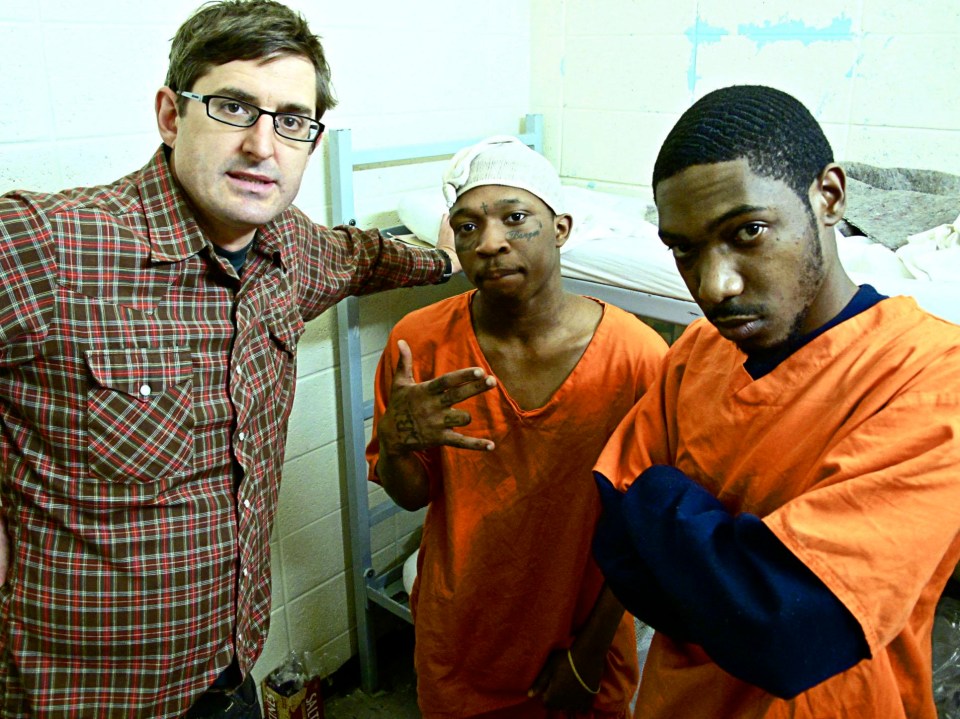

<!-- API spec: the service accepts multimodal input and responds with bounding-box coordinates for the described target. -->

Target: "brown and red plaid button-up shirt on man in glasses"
[0,148,444,719]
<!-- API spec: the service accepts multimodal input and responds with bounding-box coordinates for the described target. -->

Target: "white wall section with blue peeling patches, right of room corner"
[531,0,960,191]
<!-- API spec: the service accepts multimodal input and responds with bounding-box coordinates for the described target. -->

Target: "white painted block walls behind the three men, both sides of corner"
[0,0,960,696]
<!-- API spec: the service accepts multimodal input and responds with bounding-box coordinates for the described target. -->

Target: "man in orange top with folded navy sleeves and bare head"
[594,81,960,719]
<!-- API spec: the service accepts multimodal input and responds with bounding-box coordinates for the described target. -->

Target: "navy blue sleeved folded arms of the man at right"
[595,466,869,696]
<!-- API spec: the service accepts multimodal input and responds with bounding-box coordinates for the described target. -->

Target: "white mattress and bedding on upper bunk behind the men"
[398,187,960,324]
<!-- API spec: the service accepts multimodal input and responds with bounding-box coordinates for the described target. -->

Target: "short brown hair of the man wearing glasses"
[166,0,337,120]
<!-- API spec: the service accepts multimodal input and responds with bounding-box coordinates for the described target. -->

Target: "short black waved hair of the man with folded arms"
[653,85,833,206]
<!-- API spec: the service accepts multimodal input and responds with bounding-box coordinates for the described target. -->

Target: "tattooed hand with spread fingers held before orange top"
[377,340,497,456]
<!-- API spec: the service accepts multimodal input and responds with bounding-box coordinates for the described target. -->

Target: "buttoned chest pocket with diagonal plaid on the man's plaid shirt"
[86,349,194,483]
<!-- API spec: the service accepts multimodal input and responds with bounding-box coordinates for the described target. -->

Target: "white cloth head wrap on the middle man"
[443,135,563,214]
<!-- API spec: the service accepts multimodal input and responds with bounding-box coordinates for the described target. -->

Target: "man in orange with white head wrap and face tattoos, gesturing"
[368,138,666,719]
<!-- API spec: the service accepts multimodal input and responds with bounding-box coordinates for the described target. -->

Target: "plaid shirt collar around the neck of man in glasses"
[138,145,287,271]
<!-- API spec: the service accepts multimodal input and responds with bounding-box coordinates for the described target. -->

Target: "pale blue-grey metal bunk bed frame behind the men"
[328,114,700,693]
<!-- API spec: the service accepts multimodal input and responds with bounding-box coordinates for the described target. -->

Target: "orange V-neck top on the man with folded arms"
[596,297,960,719]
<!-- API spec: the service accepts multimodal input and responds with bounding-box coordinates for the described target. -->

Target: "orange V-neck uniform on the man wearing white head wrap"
[367,292,666,718]
